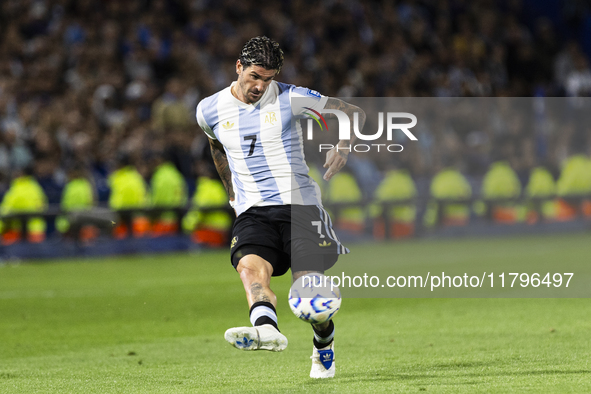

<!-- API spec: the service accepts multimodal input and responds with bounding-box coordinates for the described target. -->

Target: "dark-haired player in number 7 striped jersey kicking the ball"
[196,37,365,378]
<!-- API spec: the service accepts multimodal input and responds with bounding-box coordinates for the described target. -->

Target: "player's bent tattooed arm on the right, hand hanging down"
[324,97,366,181]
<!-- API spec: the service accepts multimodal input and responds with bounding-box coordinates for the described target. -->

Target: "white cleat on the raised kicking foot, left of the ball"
[224,324,287,352]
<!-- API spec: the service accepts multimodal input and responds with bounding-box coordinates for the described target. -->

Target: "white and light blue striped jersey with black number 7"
[196,81,328,215]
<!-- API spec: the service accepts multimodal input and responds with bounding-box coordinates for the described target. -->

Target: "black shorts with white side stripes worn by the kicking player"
[230,205,349,276]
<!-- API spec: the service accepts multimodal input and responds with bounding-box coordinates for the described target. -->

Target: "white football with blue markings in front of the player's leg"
[289,273,341,324]
